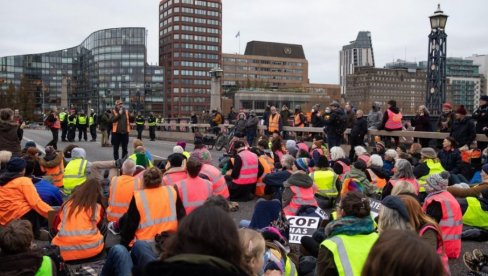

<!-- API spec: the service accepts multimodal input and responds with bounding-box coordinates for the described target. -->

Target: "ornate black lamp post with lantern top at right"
[425,4,448,116]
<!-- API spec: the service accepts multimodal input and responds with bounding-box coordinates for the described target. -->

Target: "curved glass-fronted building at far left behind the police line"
[0,28,164,119]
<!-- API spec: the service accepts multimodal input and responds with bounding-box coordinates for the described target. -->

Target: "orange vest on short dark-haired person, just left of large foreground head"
[134,186,178,241]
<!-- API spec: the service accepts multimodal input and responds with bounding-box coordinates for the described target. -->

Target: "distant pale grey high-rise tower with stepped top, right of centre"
[339,31,374,96]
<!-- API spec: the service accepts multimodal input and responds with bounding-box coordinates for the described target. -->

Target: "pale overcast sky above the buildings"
[0,0,488,83]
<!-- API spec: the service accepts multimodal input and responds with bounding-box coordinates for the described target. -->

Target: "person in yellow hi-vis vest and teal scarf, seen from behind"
[316,191,378,276]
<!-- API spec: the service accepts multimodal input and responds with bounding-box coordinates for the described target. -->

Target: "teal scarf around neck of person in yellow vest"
[325,216,374,237]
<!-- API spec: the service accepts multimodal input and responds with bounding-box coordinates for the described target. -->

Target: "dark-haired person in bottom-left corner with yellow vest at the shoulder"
[0,220,56,276]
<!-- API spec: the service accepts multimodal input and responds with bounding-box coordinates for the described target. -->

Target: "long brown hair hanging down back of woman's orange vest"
[66,178,103,216]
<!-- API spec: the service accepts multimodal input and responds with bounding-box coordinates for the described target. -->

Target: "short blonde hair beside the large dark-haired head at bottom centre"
[239,228,266,274]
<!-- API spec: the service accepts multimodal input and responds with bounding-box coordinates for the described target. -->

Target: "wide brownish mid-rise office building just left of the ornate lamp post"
[346,64,426,115]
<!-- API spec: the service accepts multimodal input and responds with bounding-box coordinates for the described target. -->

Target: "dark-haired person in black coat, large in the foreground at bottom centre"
[135,206,251,276]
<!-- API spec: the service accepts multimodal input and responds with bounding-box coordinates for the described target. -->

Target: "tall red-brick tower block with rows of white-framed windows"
[159,0,222,117]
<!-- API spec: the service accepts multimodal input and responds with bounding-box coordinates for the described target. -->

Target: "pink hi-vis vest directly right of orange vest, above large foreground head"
[176,176,212,215]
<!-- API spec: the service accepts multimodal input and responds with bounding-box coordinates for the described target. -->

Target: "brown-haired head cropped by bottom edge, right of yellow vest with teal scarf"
[361,230,444,276]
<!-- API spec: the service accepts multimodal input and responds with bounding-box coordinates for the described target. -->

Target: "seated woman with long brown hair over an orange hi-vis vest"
[52,178,107,263]
